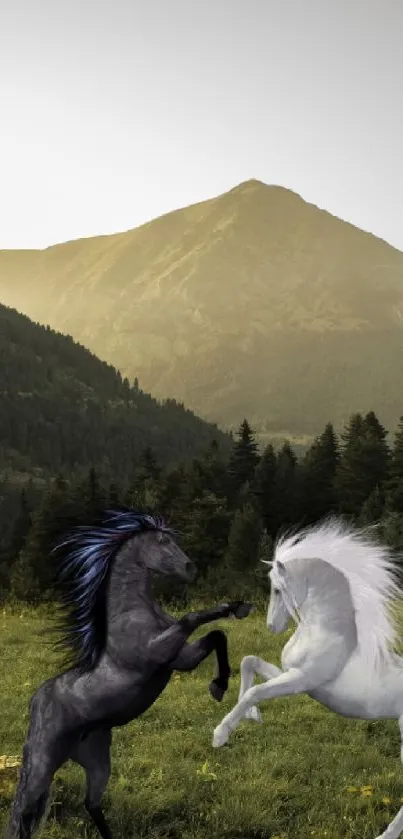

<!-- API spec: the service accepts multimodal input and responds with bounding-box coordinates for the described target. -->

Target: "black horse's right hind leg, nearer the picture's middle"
[69,728,112,839]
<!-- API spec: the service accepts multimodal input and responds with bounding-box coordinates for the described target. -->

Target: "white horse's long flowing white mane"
[272,519,403,672]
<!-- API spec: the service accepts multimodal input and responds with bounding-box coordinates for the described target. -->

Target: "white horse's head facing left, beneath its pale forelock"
[266,561,308,633]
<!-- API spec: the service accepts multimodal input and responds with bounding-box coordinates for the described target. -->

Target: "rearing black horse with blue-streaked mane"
[6,508,251,839]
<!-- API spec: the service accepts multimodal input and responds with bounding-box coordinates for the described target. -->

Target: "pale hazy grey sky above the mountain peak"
[0,0,403,250]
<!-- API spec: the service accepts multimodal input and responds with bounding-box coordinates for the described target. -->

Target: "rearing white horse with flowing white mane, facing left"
[213,520,403,839]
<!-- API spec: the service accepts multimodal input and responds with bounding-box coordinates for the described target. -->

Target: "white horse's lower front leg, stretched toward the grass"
[213,667,308,748]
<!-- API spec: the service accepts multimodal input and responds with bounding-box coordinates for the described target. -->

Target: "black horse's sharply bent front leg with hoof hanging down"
[171,629,231,702]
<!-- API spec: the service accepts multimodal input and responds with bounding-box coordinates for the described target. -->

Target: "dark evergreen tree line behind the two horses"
[0,411,403,603]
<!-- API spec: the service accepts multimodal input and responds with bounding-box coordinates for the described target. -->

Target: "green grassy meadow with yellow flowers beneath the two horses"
[0,610,403,839]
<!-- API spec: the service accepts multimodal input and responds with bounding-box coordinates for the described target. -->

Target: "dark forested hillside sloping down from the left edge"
[0,305,230,485]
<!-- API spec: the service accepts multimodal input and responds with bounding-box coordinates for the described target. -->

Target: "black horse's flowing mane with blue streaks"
[52,506,171,672]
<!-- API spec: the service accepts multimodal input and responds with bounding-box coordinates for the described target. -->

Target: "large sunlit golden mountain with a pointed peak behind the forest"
[0,181,403,437]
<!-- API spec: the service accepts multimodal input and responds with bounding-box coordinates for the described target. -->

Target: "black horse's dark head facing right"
[139,530,196,583]
